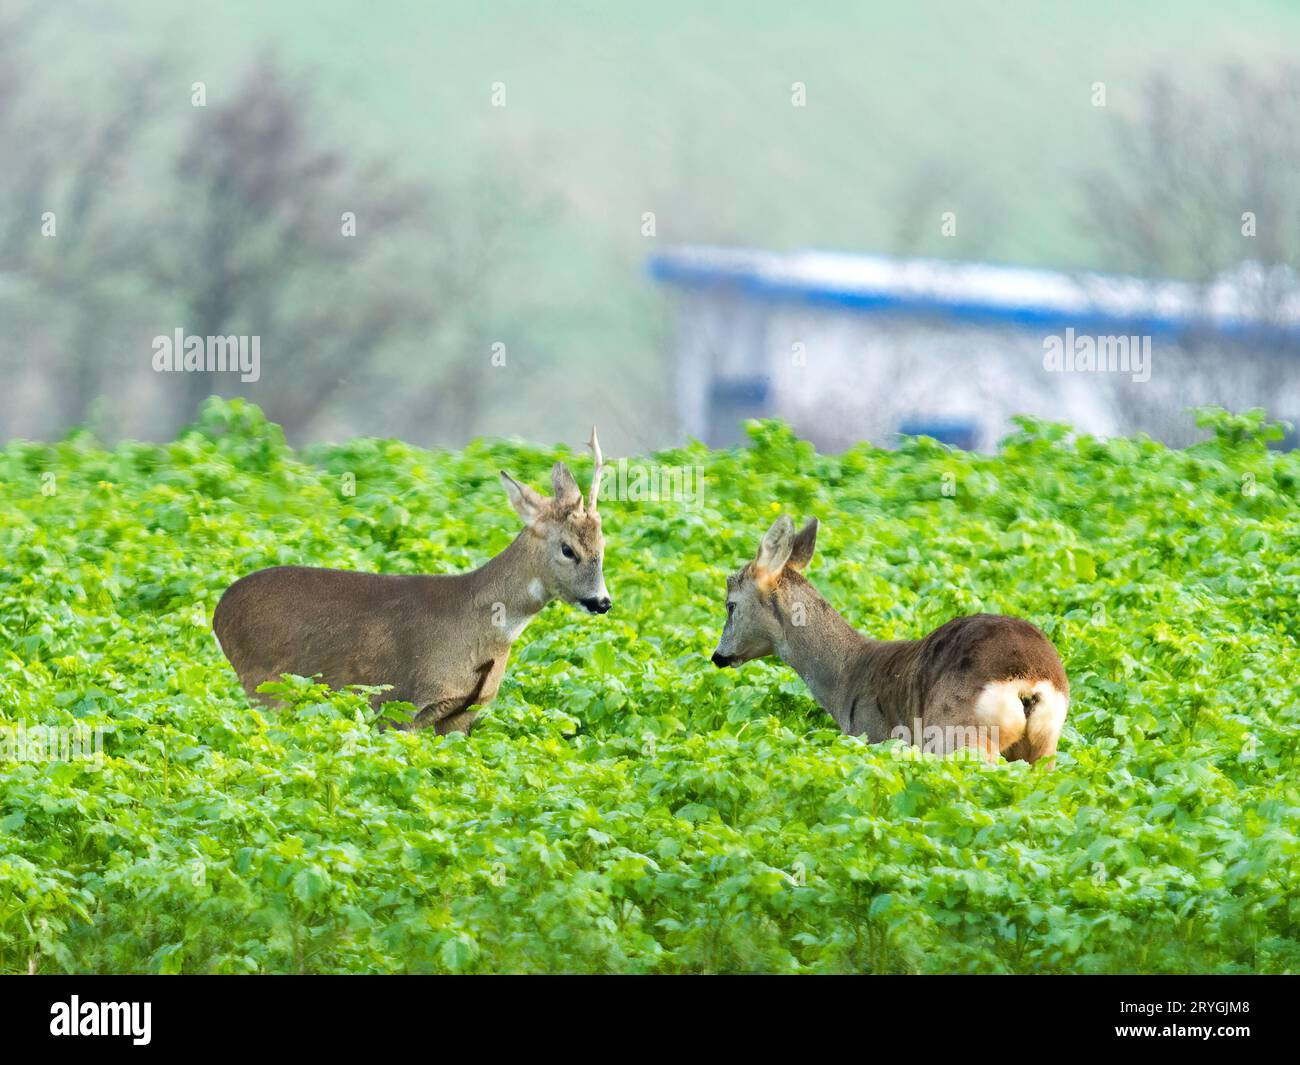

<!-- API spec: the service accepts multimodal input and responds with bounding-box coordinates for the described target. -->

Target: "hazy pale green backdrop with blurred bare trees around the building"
[0,0,1300,454]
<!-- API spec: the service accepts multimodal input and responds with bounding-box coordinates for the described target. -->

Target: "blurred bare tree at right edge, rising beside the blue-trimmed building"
[1082,64,1300,443]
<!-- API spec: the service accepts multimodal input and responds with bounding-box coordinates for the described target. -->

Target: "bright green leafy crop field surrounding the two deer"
[0,401,1300,973]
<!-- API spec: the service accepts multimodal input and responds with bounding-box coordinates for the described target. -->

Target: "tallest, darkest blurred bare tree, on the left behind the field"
[153,59,434,434]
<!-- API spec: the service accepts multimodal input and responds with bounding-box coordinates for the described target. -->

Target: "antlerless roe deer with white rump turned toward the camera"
[712,515,1070,762]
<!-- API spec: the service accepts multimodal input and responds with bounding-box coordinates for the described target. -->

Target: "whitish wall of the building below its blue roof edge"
[679,289,1300,451]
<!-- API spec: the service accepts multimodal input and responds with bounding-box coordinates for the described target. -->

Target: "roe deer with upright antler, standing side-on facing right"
[212,428,610,733]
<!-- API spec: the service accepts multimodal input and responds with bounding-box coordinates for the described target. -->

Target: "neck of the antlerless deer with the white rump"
[776,576,871,728]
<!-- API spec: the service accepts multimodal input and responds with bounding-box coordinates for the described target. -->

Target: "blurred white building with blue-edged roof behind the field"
[649,247,1300,450]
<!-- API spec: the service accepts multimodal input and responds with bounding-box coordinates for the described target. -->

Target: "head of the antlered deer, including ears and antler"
[501,425,611,614]
